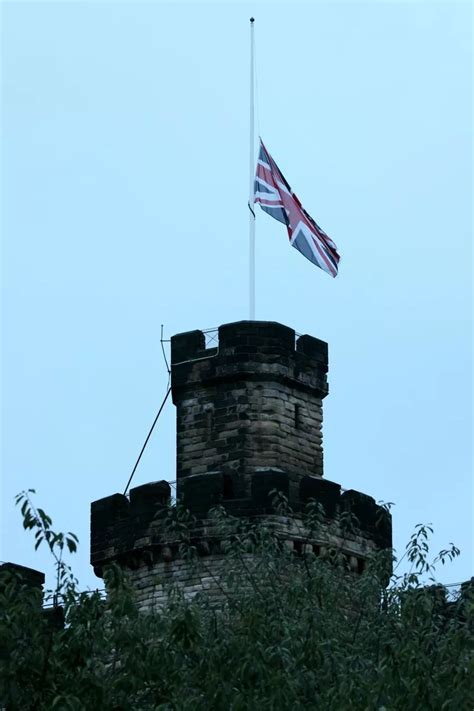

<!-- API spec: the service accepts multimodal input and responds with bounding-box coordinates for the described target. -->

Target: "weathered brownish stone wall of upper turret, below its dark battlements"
[177,381,323,496]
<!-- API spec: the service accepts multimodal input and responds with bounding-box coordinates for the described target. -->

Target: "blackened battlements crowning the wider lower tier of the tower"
[91,470,392,575]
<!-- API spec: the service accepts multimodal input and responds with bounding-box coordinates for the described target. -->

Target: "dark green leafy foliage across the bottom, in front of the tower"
[0,492,474,711]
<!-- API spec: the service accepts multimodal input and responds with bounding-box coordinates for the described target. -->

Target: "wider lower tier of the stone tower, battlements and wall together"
[91,470,391,607]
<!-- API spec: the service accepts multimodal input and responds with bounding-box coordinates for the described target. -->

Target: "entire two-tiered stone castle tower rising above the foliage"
[91,321,391,608]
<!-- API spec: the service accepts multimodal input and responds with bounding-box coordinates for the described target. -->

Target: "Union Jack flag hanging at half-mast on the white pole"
[254,140,340,277]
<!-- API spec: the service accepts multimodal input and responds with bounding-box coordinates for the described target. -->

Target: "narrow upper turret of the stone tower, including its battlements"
[171,321,327,484]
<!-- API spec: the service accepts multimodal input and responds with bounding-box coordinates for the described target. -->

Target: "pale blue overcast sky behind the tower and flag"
[0,1,474,589]
